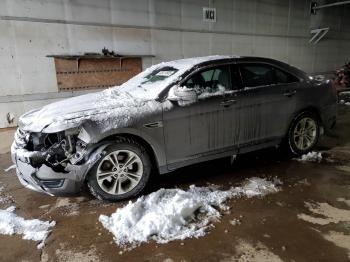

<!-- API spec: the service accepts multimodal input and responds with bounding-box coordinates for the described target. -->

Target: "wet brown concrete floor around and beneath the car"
[0,106,350,261]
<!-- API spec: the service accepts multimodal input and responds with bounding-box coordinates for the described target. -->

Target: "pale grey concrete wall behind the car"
[0,0,350,128]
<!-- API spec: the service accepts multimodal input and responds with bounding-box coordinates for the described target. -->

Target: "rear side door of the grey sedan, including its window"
[238,62,296,147]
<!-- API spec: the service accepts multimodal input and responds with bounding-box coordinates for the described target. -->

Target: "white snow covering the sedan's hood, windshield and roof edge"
[19,56,238,133]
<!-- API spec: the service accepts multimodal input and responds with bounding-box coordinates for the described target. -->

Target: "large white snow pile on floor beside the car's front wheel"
[99,177,280,248]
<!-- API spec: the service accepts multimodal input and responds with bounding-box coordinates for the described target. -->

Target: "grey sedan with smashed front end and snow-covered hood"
[11,56,336,201]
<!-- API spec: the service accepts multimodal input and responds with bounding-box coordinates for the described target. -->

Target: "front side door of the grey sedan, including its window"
[163,65,237,170]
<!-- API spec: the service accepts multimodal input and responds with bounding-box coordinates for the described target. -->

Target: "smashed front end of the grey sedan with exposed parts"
[11,129,105,195]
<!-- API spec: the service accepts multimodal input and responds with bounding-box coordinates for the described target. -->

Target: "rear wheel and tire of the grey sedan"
[287,111,320,156]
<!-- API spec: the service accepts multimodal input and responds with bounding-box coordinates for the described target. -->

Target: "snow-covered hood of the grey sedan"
[19,88,155,133]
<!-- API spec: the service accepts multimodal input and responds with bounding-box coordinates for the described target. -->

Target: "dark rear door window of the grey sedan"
[240,64,274,87]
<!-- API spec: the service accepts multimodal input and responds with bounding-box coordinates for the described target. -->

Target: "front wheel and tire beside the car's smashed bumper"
[87,138,152,202]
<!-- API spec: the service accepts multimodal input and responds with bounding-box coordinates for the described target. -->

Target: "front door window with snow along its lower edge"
[183,66,231,94]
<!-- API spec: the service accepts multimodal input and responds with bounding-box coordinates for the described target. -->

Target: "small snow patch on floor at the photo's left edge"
[0,206,56,248]
